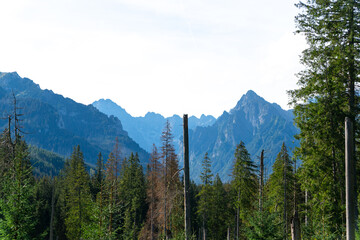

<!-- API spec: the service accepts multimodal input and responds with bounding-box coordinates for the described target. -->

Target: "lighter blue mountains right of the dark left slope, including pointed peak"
[93,90,298,181]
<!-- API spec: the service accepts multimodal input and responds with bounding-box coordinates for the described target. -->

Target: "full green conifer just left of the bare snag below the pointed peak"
[232,141,258,239]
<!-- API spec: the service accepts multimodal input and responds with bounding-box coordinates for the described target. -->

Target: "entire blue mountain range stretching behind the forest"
[0,72,298,182]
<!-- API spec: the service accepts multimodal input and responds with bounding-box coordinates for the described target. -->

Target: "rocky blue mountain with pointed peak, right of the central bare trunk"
[189,91,298,181]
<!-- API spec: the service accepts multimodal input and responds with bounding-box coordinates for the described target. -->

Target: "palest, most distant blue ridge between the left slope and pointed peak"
[92,99,216,152]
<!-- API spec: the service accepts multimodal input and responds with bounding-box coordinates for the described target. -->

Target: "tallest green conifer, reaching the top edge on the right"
[290,0,360,237]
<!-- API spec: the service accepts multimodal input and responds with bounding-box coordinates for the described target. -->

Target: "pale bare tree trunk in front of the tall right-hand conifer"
[345,117,356,240]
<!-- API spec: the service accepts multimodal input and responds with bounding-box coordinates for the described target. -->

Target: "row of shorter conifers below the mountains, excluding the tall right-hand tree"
[0,107,300,239]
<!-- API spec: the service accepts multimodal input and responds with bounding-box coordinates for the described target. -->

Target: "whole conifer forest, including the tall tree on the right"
[0,0,360,240]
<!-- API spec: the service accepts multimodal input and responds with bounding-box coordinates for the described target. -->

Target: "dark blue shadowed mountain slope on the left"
[0,72,149,164]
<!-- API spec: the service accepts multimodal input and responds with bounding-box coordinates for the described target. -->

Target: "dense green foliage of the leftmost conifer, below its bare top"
[0,138,37,240]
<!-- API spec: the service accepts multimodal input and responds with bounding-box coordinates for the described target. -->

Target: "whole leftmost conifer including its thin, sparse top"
[0,105,38,240]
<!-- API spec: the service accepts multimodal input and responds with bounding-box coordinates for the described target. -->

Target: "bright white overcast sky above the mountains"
[0,0,306,117]
